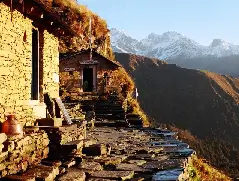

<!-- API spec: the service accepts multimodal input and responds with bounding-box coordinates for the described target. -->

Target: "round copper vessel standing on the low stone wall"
[2,114,23,135]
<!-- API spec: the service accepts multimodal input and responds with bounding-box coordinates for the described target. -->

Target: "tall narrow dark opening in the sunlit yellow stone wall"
[31,29,39,100]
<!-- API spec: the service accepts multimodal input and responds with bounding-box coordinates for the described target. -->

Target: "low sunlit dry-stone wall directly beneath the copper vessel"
[0,131,49,177]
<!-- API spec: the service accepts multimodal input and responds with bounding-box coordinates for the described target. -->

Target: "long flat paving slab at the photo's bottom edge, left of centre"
[90,170,134,180]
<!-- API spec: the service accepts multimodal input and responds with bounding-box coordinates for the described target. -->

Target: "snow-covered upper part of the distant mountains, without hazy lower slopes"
[111,28,239,60]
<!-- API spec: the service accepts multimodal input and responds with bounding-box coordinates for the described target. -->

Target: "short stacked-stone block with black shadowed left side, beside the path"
[41,124,86,159]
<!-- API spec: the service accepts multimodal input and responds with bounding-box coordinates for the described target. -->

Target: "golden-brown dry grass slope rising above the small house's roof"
[33,0,110,55]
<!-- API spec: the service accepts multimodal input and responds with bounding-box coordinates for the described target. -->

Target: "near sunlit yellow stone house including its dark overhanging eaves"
[0,0,72,125]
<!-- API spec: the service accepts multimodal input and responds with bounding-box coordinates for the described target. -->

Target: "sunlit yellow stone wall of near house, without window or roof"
[0,3,59,125]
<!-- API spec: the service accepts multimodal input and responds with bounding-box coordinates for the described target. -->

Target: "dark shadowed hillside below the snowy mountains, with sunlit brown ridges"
[115,53,239,176]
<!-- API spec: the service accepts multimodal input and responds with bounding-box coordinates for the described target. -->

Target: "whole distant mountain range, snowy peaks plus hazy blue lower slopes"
[111,28,239,77]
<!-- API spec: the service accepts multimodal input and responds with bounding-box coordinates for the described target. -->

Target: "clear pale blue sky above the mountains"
[78,0,239,45]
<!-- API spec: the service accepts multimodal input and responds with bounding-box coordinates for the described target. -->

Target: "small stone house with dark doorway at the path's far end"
[60,49,121,96]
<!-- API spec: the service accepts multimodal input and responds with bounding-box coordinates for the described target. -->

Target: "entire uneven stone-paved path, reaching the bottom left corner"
[1,127,194,181]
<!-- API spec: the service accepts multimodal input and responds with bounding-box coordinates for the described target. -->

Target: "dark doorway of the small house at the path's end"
[83,68,94,92]
